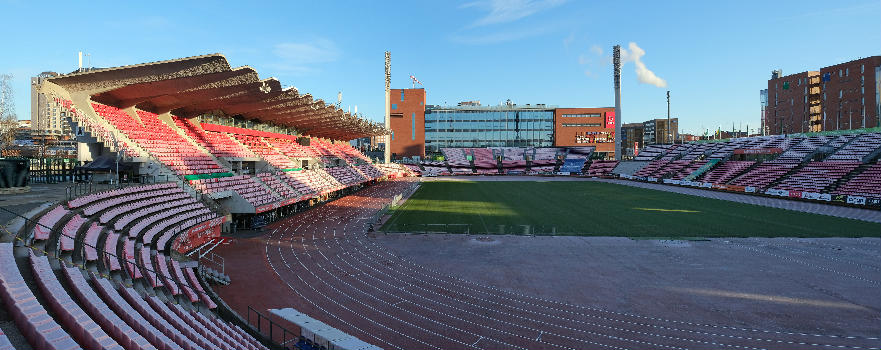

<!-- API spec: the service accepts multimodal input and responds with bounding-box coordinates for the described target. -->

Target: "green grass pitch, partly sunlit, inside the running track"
[381,181,881,237]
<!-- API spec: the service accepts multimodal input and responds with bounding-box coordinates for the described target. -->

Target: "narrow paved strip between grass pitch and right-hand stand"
[594,179,881,223]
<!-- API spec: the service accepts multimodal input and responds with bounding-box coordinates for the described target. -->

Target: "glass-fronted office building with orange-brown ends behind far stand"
[389,89,615,158]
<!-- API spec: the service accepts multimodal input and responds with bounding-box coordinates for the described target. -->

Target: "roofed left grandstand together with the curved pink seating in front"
[0,54,412,349]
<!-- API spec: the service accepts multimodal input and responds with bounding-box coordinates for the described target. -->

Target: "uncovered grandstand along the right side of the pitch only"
[617,129,881,208]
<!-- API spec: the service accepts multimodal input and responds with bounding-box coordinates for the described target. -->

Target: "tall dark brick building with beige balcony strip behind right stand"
[762,56,881,135]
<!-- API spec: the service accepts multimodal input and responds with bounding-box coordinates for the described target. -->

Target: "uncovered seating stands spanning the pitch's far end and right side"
[408,128,881,208]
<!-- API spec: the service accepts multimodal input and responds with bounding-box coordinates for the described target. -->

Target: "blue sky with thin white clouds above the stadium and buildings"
[0,0,881,133]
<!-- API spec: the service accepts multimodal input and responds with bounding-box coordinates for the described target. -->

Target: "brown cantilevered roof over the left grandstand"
[48,54,391,140]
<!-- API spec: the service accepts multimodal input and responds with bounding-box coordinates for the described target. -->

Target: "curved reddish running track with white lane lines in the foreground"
[217,179,881,350]
